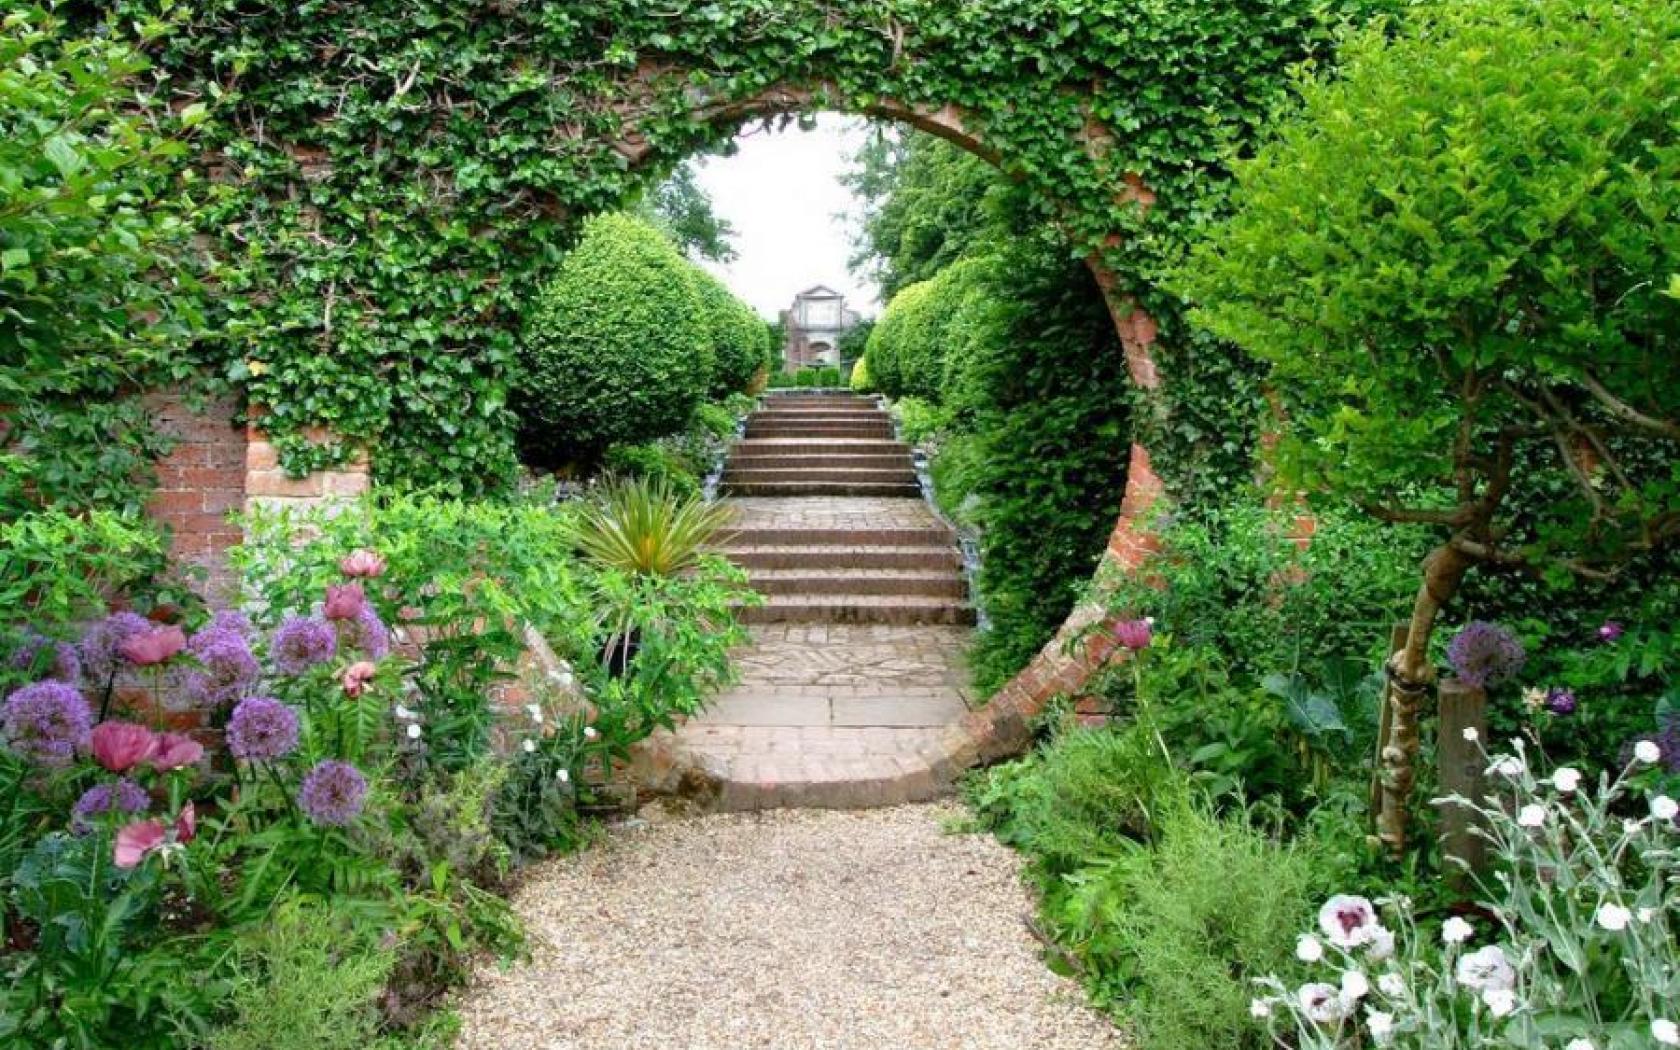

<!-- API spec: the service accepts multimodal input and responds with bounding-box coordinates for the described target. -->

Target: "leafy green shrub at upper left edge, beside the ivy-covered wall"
[0,5,205,521]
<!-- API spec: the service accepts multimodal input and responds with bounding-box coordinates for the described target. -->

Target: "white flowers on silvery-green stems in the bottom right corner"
[1253,731,1680,1050]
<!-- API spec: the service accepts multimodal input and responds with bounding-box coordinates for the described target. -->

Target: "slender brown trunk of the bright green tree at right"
[1376,543,1475,853]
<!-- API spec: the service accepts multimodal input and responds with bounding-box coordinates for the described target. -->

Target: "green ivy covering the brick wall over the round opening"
[121,0,1399,492]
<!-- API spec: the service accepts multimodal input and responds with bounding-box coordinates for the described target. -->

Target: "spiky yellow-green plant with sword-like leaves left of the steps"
[573,477,732,576]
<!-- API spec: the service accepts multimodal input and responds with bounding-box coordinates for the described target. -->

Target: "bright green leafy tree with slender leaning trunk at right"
[1181,0,1680,847]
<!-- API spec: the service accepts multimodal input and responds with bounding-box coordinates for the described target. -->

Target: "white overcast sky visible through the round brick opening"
[696,113,880,319]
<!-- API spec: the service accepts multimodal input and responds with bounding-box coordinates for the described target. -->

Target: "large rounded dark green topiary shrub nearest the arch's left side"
[516,215,712,462]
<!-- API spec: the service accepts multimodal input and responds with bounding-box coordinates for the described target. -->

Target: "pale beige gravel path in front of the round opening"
[459,805,1122,1050]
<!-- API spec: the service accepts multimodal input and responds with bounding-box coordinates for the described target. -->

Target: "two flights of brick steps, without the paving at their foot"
[719,393,974,625]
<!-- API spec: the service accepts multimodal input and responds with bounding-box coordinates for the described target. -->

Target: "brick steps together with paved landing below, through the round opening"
[655,393,974,808]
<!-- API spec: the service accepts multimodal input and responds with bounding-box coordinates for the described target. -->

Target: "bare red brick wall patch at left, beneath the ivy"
[146,393,245,598]
